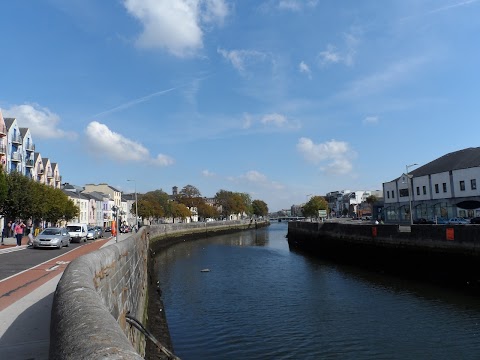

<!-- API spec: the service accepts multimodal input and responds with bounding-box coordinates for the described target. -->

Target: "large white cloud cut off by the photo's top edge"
[124,0,228,57]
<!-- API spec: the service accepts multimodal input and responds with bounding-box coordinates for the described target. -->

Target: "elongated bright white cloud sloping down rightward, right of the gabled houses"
[85,121,174,166]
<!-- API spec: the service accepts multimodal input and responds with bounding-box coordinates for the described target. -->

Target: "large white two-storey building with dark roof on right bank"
[383,147,480,222]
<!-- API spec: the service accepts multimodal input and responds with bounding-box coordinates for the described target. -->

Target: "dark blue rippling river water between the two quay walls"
[157,223,480,360]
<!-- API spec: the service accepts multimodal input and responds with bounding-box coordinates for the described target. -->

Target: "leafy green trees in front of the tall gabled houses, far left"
[0,171,79,224]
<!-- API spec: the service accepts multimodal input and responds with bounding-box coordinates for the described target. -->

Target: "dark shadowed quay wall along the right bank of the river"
[287,222,480,291]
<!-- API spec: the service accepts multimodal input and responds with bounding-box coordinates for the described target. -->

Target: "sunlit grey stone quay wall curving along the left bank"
[49,220,268,359]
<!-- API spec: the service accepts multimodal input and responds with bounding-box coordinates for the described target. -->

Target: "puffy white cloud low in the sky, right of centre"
[297,137,354,174]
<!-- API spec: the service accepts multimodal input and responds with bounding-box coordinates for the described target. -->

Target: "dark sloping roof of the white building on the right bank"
[409,147,480,177]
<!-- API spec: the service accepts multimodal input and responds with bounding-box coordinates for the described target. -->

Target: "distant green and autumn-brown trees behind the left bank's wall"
[131,185,268,220]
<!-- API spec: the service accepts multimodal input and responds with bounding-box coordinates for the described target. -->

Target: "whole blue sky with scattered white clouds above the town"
[0,0,480,211]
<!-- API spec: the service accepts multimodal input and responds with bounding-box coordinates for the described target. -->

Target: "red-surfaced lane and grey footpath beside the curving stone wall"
[0,234,128,360]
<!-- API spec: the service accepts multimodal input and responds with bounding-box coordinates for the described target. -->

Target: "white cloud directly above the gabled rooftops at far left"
[3,104,76,140]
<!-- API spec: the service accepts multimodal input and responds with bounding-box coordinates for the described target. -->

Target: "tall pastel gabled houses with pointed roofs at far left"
[0,110,62,189]
